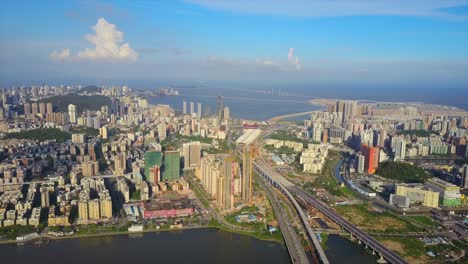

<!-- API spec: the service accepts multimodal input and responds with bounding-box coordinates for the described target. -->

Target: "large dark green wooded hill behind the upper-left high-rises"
[40,93,111,113]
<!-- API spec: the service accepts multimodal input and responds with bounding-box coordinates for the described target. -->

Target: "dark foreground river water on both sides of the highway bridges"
[0,229,376,264]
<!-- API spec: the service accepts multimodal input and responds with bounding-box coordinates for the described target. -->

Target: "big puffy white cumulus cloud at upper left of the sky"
[50,18,138,61]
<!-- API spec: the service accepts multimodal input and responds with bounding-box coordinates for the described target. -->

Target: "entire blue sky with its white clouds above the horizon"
[0,0,468,87]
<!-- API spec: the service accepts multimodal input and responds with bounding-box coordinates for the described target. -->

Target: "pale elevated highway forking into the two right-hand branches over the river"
[254,160,407,264]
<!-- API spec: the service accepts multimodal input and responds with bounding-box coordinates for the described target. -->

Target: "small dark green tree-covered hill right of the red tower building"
[375,161,432,183]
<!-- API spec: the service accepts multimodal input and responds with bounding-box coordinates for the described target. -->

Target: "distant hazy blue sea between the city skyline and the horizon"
[150,84,468,121]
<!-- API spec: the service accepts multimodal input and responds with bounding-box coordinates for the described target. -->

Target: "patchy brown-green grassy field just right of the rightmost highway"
[335,204,422,233]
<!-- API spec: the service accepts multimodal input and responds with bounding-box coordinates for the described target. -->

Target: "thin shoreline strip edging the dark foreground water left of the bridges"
[0,226,284,247]
